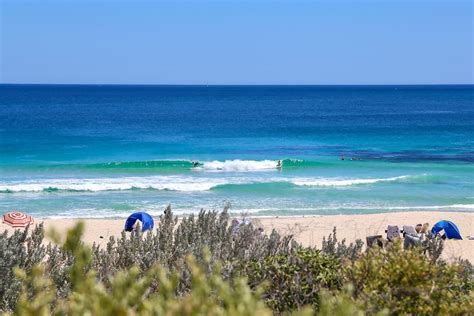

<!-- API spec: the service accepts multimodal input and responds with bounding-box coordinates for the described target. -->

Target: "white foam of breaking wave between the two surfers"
[200,159,277,171]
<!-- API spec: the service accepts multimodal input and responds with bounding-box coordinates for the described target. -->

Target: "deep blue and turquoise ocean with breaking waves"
[0,85,474,217]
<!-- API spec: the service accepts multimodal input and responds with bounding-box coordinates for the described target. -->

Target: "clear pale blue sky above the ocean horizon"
[0,0,474,84]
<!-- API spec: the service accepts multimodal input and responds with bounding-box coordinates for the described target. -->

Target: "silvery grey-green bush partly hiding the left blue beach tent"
[92,207,292,291]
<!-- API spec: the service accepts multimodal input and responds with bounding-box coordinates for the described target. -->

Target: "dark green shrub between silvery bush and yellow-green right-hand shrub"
[244,247,341,312]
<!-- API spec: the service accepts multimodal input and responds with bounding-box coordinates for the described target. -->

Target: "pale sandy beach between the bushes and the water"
[0,212,474,262]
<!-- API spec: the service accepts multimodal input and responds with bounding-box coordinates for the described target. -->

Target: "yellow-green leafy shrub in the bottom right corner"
[345,242,474,315]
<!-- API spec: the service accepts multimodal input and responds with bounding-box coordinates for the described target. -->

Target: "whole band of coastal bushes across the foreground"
[0,208,474,315]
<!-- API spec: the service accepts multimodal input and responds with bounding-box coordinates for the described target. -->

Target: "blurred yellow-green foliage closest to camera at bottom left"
[12,225,271,316]
